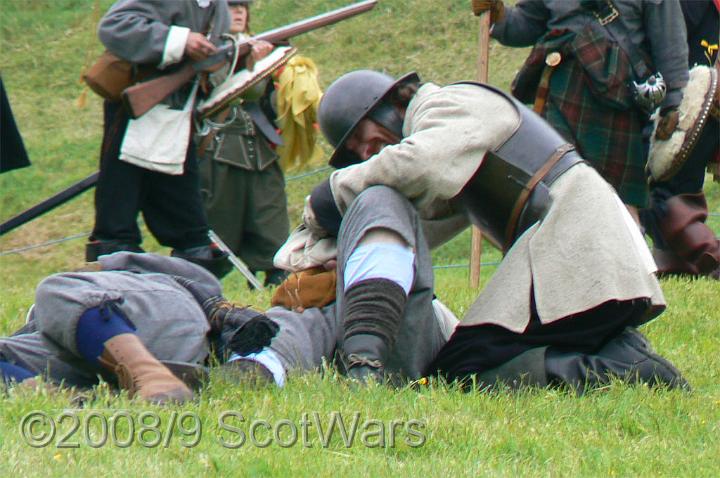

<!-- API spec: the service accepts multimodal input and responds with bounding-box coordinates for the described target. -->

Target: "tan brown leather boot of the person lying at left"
[98,334,193,404]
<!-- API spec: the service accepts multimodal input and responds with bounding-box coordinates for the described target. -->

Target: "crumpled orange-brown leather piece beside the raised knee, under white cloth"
[270,267,337,312]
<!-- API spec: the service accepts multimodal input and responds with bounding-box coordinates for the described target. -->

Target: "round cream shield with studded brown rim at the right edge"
[646,66,718,182]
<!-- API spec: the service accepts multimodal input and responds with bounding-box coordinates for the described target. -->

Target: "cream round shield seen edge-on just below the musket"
[196,46,297,119]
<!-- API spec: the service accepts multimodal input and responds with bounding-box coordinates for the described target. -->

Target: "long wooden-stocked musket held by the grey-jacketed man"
[122,0,377,118]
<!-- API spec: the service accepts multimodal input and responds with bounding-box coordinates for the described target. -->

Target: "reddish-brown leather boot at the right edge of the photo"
[656,192,720,275]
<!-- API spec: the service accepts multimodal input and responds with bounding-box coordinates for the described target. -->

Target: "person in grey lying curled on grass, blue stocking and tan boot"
[0,252,277,403]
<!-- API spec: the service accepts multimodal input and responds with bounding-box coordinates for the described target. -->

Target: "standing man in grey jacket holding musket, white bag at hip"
[87,0,230,275]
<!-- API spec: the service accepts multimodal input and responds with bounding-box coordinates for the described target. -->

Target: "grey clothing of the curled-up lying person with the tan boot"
[0,252,215,387]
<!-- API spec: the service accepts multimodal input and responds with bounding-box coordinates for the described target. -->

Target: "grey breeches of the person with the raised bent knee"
[266,186,454,379]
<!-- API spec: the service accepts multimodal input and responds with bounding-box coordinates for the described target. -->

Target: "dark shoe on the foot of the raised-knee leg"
[343,334,388,383]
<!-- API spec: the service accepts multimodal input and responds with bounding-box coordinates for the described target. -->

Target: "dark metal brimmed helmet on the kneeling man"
[318,70,420,168]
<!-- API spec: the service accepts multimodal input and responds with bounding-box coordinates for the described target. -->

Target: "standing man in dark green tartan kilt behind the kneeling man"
[472,0,688,222]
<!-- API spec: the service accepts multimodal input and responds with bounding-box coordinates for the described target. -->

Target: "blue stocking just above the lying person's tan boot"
[75,302,135,365]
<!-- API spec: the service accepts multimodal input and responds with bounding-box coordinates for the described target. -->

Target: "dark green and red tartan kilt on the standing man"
[542,58,649,208]
